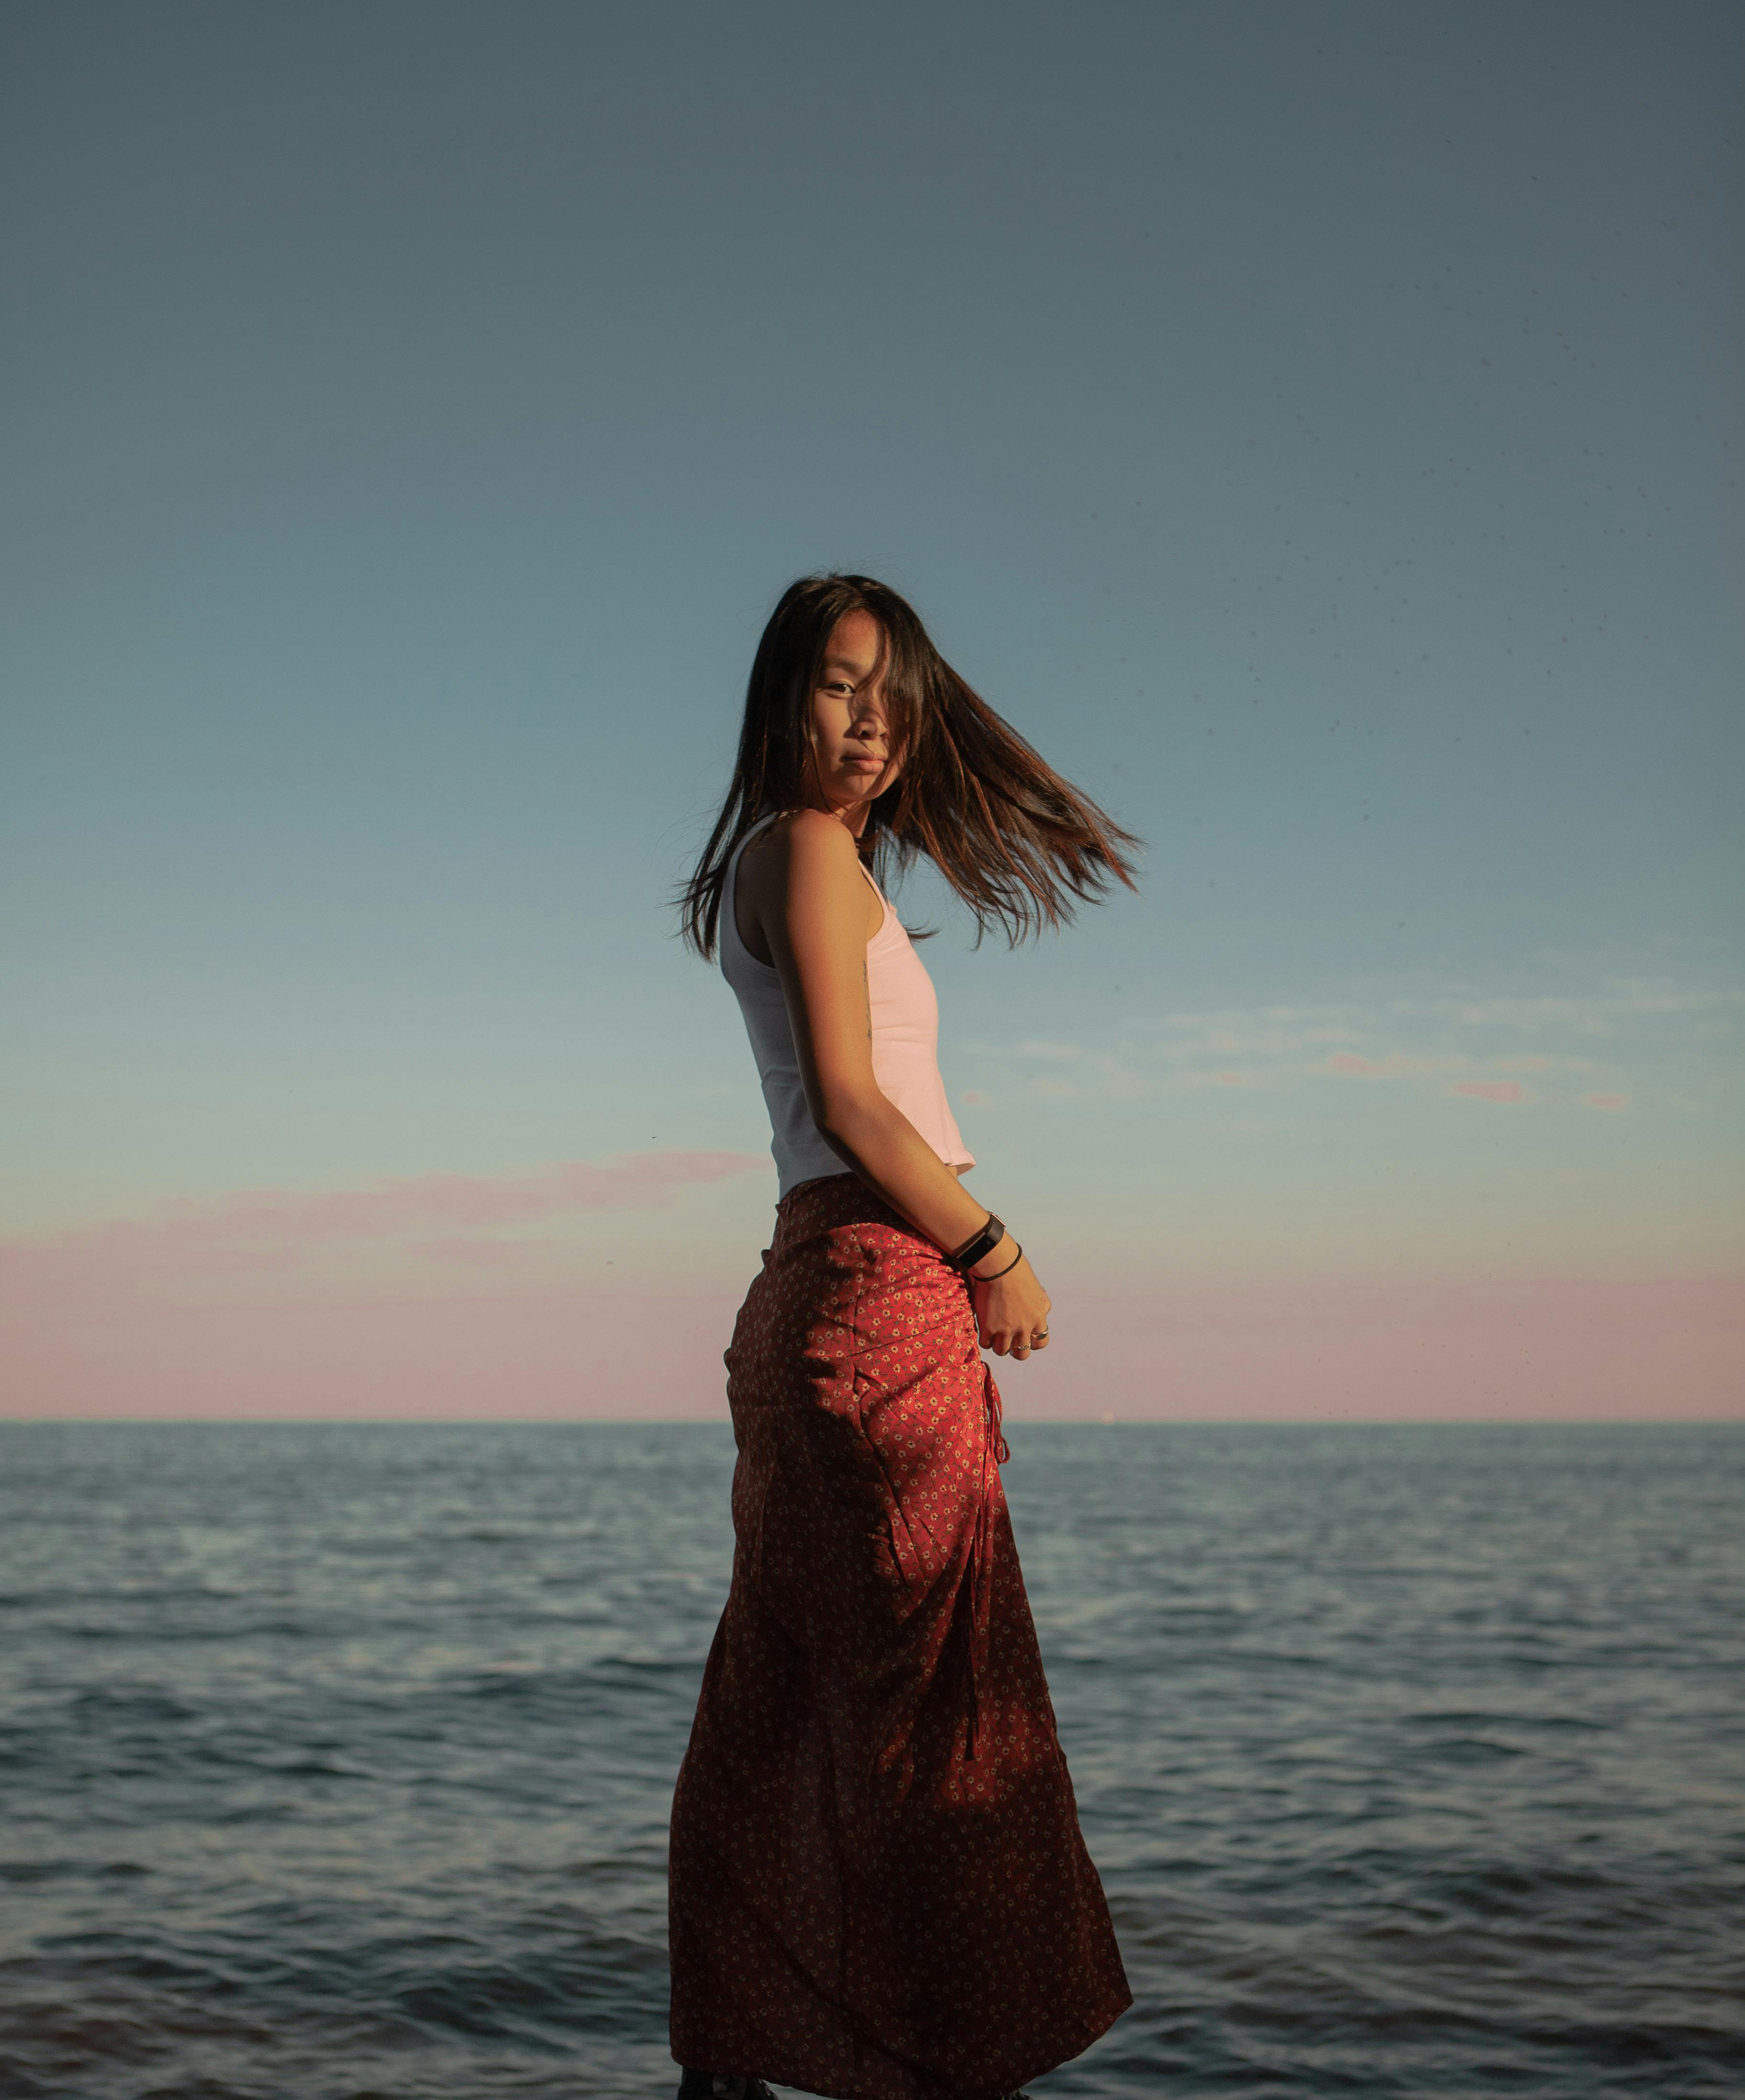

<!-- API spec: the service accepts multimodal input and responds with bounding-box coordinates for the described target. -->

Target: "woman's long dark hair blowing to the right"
[678,575,1140,960]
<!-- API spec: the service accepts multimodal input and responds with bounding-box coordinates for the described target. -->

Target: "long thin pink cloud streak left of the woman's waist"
[0,1151,768,1308]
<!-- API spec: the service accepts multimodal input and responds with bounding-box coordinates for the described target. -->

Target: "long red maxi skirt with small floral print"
[670,1174,1132,2100]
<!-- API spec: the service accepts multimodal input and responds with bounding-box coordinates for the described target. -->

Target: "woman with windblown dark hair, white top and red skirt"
[670,575,1138,2100]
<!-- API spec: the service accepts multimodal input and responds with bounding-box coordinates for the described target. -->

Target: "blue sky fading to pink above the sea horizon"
[0,0,1745,1420]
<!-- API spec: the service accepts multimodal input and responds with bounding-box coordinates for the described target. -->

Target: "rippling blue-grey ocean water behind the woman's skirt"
[0,1422,1745,2100]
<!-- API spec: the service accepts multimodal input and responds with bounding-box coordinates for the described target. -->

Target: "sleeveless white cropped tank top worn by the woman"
[720,817,974,1201]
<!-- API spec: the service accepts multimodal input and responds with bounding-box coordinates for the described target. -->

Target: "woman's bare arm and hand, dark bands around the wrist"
[758,810,1048,1355]
